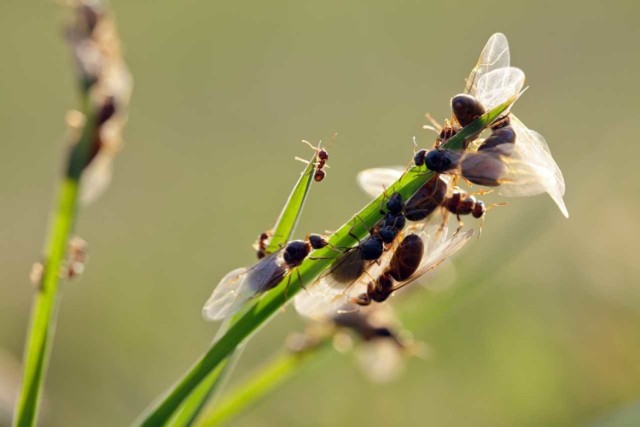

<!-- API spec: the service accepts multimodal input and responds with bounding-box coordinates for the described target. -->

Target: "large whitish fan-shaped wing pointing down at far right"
[499,114,569,218]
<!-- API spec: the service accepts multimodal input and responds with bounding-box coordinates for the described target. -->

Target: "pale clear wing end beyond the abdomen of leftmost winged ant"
[202,267,253,321]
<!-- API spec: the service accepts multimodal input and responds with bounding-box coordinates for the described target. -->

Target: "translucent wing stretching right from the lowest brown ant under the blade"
[394,224,474,291]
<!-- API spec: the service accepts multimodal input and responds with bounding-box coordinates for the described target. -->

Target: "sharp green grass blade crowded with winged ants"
[140,97,516,427]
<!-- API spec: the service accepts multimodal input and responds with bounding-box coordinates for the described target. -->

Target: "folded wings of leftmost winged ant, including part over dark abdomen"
[202,251,286,321]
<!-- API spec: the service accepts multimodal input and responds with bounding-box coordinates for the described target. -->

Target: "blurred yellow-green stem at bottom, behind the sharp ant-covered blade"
[195,339,331,427]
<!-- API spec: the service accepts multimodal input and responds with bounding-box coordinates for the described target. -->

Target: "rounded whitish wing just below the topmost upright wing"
[471,67,525,114]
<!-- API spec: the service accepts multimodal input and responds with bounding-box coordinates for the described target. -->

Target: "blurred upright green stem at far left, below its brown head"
[14,178,79,427]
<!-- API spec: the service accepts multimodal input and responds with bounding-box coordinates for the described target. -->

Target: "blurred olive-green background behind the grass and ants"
[0,0,640,427]
